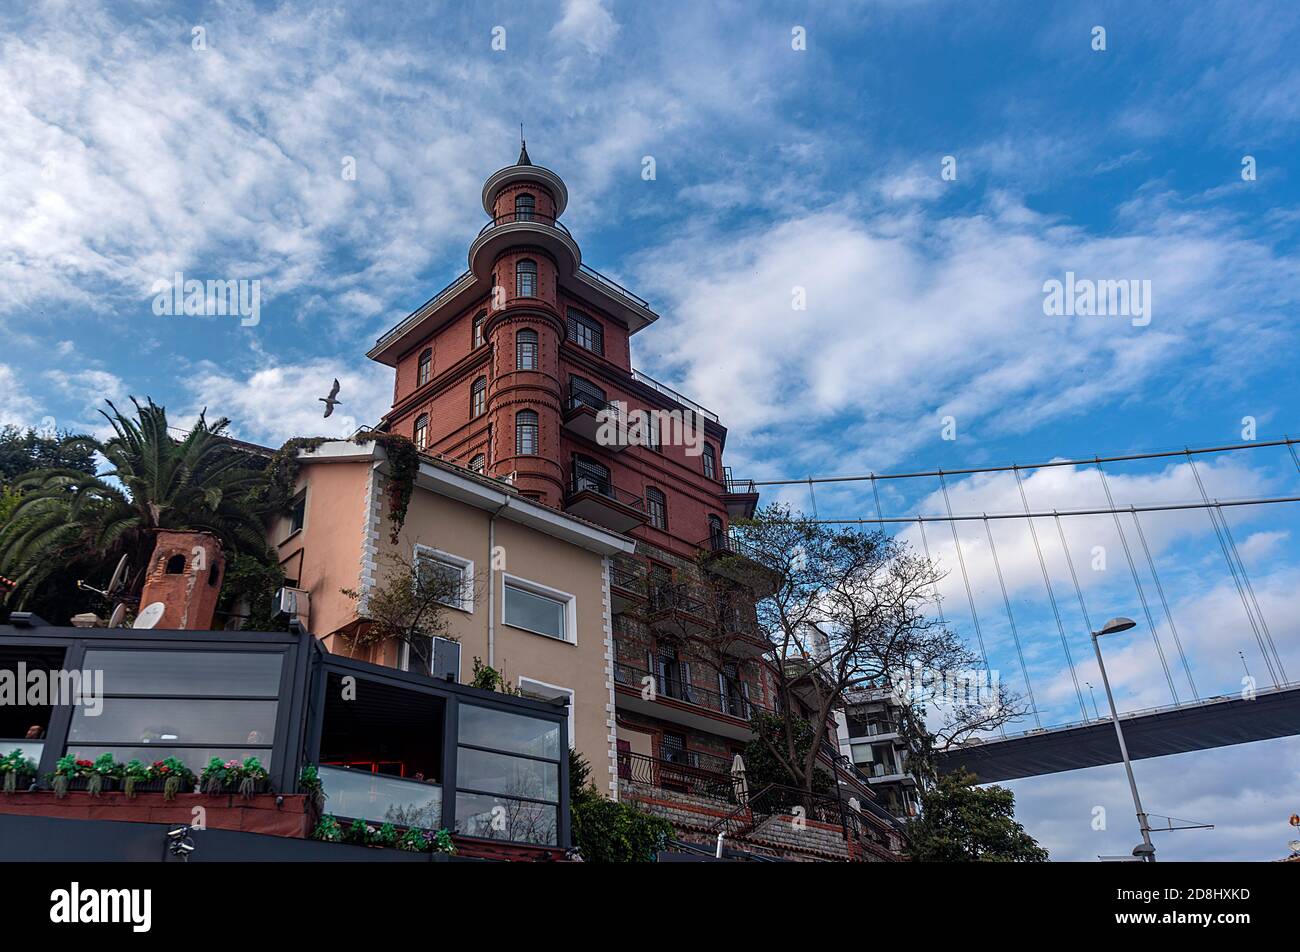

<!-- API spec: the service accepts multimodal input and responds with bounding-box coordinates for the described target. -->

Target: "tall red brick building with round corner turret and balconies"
[369,143,904,863]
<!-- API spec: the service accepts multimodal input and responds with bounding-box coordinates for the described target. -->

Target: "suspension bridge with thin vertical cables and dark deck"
[751,437,1300,783]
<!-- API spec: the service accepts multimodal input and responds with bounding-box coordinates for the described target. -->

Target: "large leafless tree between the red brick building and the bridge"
[681,506,1023,791]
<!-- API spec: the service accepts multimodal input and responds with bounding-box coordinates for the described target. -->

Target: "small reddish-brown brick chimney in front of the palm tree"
[140,529,226,631]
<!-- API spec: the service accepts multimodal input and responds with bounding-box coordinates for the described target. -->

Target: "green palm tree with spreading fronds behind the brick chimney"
[0,397,270,605]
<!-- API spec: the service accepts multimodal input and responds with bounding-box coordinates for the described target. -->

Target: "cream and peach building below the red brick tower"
[272,441,633,797]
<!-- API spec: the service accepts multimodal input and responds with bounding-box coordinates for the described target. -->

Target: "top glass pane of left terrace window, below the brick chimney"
[82,650,285,697]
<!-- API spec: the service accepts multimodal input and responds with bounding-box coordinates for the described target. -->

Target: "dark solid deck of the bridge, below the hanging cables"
[939,684,1300,783]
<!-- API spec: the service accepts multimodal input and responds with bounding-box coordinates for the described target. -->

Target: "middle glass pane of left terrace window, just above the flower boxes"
[68,697,278,747]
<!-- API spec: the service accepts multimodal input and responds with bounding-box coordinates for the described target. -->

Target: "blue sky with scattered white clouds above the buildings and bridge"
[0,0,1300,858]
